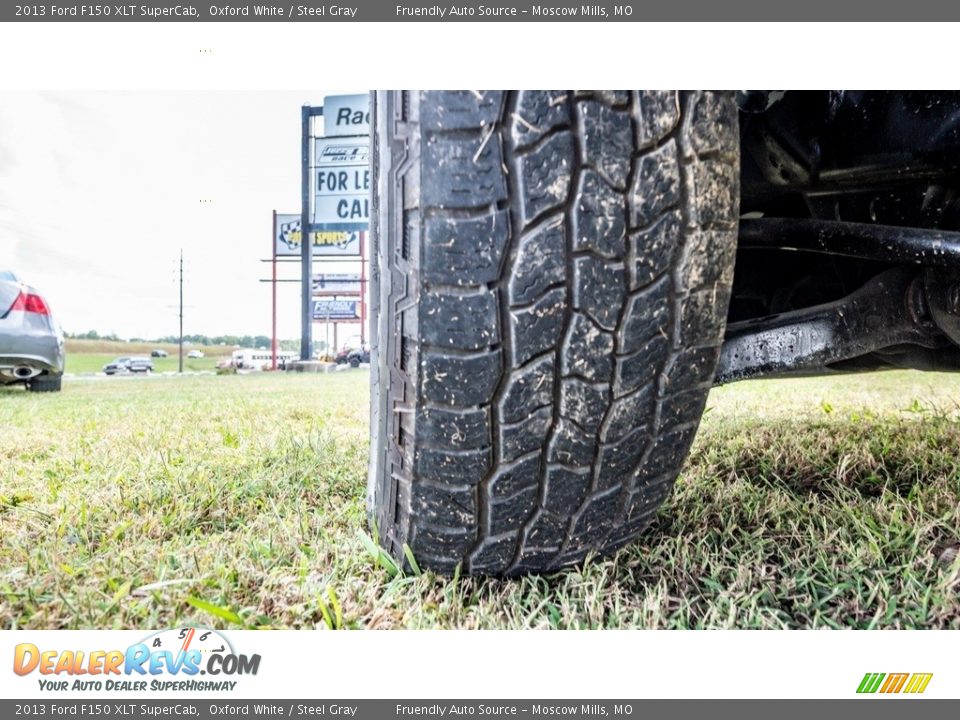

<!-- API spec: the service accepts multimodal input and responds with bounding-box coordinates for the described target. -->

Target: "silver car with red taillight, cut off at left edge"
[0,270,64,392]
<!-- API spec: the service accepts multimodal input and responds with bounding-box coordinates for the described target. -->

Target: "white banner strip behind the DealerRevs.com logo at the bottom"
[0,630,960,699]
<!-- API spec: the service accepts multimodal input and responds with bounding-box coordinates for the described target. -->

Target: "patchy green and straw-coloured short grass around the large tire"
[0,371,960,629]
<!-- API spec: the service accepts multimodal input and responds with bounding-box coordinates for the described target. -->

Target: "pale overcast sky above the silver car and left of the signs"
[0,91,358,339]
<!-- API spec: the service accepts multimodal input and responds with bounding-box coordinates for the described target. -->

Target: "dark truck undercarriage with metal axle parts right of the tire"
[715,91,960,384]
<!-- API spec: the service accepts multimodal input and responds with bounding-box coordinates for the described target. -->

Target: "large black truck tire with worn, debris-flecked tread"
[368,91,739,575]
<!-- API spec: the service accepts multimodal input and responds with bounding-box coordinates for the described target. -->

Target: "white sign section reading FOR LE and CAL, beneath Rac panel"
[312,138,370,230]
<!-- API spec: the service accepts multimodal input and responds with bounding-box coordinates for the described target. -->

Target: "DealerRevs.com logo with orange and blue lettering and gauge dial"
[13,627,260,692]
